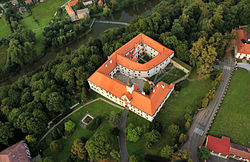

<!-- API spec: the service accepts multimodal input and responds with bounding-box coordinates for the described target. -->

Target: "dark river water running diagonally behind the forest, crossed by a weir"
[0,0,160,86]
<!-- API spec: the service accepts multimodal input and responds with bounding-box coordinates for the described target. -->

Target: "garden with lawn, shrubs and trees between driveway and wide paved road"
[126,69,212,161]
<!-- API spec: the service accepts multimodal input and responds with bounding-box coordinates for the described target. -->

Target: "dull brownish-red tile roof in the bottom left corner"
[0,141,29,162]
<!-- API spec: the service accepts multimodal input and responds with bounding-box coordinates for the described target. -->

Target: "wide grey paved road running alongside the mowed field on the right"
[182,56,233,162]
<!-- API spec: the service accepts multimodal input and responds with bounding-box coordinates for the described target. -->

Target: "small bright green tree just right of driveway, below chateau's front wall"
[125,123,142,142]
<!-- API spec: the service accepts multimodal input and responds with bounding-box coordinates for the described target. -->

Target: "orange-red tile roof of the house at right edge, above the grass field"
[236,30,250,55]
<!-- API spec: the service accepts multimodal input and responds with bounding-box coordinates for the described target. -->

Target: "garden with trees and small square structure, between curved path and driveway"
[41,101,122,162]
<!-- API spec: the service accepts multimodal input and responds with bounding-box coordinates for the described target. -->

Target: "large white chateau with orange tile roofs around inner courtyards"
[88,33,174,121]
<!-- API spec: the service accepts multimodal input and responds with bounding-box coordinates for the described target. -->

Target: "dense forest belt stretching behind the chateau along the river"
[0,0,250,158]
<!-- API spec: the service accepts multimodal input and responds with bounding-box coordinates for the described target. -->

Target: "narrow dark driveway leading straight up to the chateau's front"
[119,109,129,162]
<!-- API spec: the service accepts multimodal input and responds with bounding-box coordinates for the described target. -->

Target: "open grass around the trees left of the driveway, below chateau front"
[44,101,122,162]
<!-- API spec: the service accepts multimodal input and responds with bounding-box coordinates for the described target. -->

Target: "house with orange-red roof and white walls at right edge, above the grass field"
[235,29,250,60]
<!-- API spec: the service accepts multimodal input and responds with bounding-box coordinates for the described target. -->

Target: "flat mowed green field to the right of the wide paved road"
[209,69,250,147]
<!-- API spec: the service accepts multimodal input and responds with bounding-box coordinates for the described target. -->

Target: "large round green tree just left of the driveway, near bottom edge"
[85,132,111,160]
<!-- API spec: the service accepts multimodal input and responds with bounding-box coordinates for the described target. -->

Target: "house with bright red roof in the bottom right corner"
[206,136,250,162]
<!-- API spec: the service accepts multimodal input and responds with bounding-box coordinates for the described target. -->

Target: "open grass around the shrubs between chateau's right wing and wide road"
[127,76,212,160]
